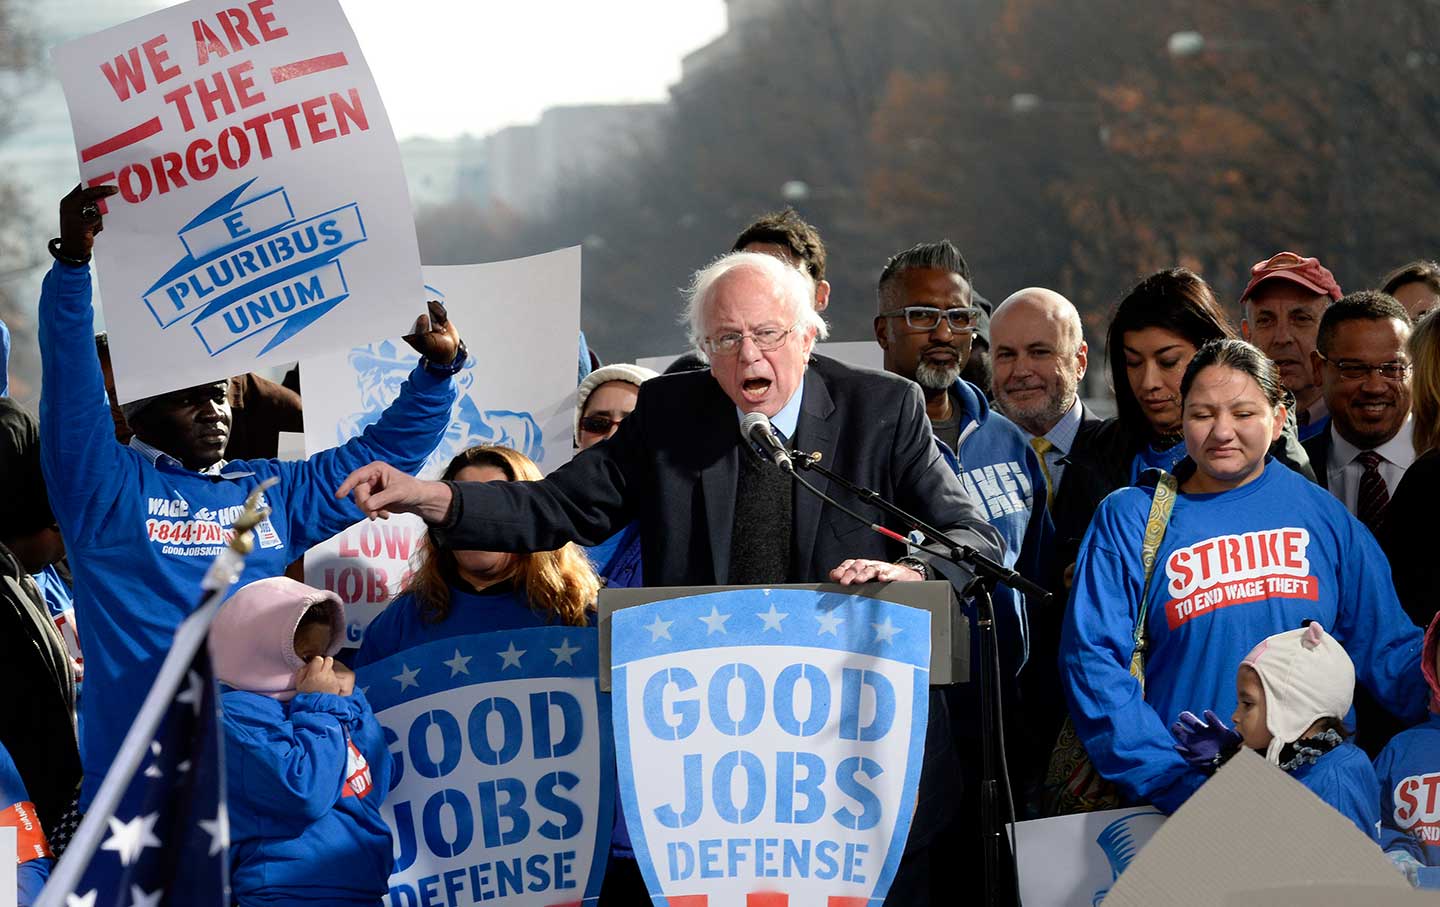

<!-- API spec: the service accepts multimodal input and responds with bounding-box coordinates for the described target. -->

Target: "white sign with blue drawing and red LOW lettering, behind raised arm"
[300,246,580,645]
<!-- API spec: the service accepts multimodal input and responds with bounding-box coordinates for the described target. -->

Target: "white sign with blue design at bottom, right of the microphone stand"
[1015,806,1165,907]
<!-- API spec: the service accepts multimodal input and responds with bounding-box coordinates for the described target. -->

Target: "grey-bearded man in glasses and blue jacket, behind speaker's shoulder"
[874,240,1051,868]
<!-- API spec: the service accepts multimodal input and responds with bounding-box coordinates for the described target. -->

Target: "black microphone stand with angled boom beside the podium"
[791,451,1050,907]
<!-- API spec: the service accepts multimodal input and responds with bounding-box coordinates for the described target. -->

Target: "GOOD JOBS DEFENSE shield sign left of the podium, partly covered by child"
[356,626,615,907]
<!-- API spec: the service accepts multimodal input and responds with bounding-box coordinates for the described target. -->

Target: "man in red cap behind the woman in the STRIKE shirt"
[1240,252,1344,441]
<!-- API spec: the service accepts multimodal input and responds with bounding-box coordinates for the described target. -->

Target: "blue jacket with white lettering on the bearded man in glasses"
[935,379,1054,677]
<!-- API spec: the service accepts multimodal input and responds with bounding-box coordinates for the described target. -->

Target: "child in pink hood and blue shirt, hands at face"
[210,576,393,907]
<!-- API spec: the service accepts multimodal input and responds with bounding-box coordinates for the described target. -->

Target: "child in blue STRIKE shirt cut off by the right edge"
[1375,613,1440,888]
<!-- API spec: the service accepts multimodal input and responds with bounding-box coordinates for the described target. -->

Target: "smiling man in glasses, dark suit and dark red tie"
[1305,289,1416,531]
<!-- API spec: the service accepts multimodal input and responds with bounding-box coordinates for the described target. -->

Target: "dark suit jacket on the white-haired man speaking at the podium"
[444,356,1002,586]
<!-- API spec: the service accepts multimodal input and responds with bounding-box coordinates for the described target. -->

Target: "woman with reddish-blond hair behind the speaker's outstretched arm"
[356,445,600,668]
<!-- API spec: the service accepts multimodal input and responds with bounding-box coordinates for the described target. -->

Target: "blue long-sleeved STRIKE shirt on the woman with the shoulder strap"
[1060,458,1428,812]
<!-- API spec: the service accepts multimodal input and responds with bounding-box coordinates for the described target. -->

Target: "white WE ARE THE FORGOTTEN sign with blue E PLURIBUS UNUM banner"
[55,0,423,402]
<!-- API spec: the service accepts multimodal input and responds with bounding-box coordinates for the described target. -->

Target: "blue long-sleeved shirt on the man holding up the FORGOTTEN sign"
[40,262,455,809]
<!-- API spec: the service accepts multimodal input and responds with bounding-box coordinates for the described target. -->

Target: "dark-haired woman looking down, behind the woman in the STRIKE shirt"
[1054,268,1315,581]
